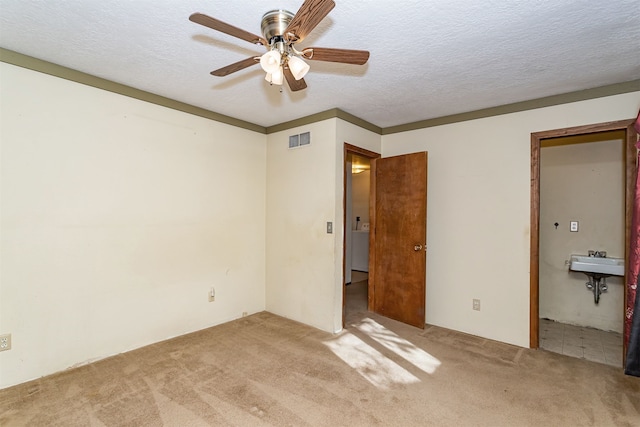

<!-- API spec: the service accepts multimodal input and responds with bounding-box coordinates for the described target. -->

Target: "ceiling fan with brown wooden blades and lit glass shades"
[189,0,369,92]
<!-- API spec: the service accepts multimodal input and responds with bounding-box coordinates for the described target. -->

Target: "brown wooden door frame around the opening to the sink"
[529,119,638,357]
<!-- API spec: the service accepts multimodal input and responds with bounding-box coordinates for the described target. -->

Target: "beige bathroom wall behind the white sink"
[540,140,625,332]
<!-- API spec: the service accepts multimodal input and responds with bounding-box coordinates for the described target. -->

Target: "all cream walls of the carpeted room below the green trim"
[0,63,640,387]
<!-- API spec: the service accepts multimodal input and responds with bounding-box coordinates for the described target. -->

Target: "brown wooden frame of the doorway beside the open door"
[342,142,382,328]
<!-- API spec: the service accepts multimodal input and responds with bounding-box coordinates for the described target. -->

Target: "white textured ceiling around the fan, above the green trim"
[0,0,640,128]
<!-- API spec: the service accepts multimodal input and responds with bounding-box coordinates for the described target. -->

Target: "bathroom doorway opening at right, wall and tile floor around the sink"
[539,130,625,367]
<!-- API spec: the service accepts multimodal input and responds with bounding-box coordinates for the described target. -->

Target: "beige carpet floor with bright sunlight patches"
[0,304,640,426]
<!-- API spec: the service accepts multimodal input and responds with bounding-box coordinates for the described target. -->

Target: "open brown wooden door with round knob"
[369,152,427,328]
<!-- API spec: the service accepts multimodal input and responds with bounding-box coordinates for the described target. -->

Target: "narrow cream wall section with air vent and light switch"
[266,119,380,332]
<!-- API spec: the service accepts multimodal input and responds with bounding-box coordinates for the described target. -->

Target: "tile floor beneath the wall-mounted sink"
[539,319,622,367]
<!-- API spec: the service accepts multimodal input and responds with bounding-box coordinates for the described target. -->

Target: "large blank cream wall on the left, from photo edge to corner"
[0,63,266,387]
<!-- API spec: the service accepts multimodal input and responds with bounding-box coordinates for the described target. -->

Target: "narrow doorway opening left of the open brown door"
[342,143,380,327]
